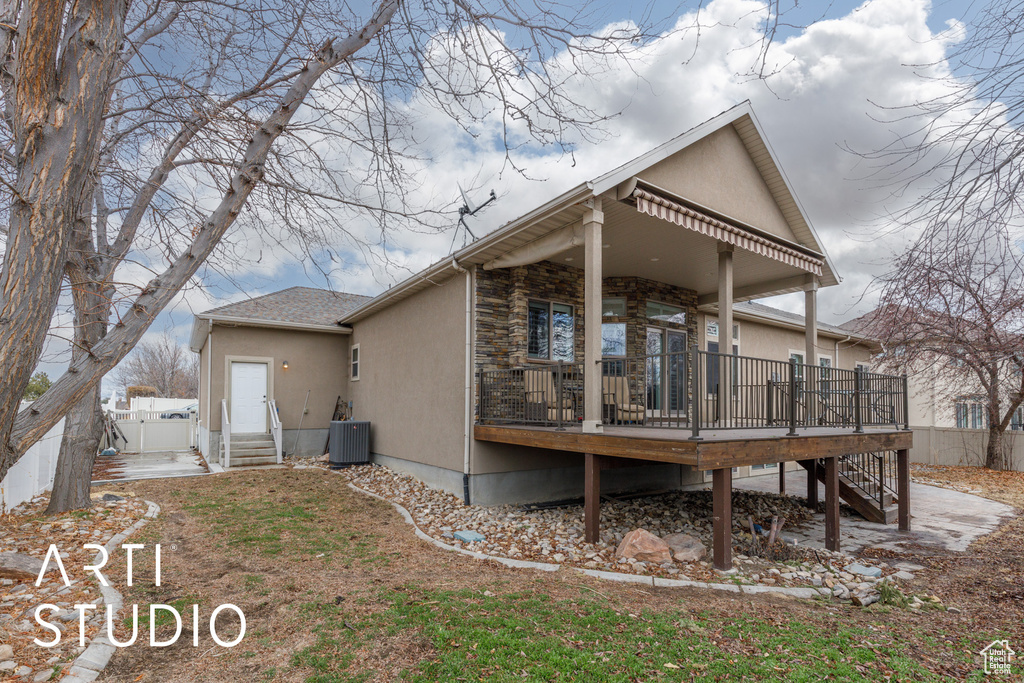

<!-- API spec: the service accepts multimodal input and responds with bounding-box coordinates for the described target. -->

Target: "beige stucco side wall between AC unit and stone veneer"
[346,274,468,474]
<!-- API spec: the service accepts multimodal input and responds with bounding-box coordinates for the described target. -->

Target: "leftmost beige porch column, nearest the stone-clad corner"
[583,197,604,434]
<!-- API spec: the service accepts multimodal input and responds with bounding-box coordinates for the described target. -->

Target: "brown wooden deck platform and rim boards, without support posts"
[473,425,913,470]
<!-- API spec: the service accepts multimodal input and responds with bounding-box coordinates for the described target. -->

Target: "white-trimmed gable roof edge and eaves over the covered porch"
[339,101,840,324]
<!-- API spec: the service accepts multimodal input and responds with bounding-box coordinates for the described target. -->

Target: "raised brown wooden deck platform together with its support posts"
[473,425,913,570]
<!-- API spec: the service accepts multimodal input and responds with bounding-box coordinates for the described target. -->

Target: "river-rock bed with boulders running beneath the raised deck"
[341,465,936,604]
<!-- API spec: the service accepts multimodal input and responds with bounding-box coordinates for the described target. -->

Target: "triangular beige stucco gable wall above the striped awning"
[640,126,798,242]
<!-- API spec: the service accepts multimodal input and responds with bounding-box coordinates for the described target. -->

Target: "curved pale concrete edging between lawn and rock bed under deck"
[348,481,831,599]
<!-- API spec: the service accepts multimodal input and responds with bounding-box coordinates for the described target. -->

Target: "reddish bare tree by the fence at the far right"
[856,220,1024,469]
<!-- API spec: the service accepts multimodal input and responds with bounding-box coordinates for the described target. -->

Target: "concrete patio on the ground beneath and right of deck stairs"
[733,470,1014,553]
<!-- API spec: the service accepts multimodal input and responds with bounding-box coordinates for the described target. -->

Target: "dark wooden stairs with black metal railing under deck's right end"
[800,453,899,524]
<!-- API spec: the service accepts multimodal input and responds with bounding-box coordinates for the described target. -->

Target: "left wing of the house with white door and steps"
[189,287,370,465]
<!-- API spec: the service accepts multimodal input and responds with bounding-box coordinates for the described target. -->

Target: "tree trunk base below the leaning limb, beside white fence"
[46,384,103,514]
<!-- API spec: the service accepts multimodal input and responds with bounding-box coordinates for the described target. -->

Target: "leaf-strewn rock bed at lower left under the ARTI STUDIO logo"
[0,492,148,681]
